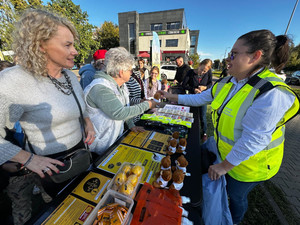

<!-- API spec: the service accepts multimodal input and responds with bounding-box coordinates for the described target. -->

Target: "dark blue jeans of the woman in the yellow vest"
[226,174,262,224]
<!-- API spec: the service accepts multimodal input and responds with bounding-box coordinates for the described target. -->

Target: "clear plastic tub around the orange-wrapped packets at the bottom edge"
[83,190,134,225]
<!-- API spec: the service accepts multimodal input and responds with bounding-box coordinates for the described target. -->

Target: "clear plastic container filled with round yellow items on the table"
[107,162,145,199]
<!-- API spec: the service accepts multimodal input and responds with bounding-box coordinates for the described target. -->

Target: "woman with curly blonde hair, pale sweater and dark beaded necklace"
[0,9,95,224]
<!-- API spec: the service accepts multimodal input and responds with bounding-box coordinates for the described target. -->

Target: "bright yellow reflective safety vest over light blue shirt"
[211,69,299,182]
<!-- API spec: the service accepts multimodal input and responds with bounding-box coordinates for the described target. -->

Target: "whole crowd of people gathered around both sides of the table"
[0,9,299,224]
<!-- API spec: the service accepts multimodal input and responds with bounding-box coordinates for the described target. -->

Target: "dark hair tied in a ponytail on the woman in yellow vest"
[238,30,290,73]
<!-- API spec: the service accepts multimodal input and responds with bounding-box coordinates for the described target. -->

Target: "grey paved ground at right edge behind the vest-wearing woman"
[271,115,300,218]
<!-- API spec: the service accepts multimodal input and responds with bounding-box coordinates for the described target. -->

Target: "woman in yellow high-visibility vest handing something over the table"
[158,30,299,224]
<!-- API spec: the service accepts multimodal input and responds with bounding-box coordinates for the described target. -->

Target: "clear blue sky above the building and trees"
[73,0,300,60]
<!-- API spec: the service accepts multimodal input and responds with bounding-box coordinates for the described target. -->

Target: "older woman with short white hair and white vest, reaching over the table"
[84,47,157,155]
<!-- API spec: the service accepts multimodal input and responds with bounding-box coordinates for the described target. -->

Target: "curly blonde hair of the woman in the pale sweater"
[13,9,78,76]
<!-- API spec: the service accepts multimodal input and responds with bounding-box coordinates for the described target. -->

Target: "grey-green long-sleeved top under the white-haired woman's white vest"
[86,71,149,129]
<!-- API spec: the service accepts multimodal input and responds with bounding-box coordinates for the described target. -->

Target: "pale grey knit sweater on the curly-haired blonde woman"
[0,66,85,165]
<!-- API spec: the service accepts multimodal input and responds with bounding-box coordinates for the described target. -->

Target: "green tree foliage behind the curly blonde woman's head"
[0,0,98,63]
